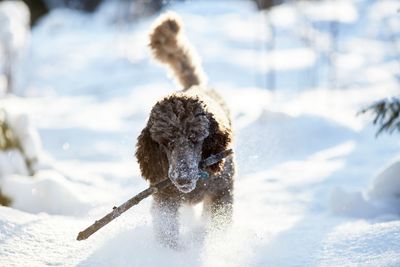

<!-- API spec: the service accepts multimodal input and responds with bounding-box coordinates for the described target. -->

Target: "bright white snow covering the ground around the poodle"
[0,0,400,267]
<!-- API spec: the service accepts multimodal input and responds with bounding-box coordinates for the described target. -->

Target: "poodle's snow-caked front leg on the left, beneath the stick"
[152,194,180,249]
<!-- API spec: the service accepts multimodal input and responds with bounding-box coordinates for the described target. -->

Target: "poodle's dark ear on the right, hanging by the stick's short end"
[202,113,232,174]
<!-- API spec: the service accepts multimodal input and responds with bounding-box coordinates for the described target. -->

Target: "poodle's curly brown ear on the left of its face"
[136,125,168,183]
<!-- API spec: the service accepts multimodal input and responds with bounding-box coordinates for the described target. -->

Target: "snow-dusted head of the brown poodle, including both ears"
[136,95,231,193]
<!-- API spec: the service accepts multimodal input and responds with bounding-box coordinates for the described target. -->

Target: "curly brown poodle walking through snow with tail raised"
[136,14,235,249]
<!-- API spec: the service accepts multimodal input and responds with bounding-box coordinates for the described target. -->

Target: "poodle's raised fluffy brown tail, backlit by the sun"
[150,13,204,90]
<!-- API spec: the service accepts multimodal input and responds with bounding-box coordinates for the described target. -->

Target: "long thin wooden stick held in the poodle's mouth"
[76,149,233,241]
